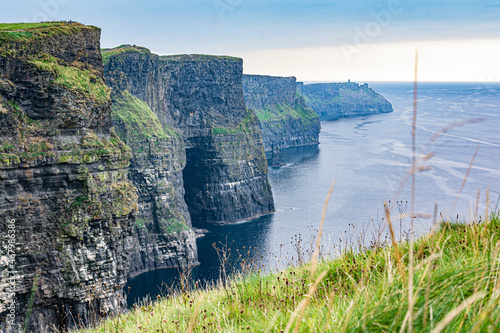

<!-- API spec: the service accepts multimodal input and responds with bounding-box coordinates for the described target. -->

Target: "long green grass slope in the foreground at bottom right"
[78,210,500,332]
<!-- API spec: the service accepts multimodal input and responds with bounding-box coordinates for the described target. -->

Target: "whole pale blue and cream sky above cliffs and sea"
[0,0,500,82]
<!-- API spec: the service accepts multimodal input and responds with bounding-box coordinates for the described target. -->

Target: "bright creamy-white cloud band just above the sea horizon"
[237,39,500,82]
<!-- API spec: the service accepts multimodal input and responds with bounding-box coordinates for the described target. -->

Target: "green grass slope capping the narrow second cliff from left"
[111,91,178,140]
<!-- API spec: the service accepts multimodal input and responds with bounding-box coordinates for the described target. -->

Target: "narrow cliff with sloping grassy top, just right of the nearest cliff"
[111,90,197,277]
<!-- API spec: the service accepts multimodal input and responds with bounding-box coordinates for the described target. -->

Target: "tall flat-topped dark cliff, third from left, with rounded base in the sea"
[103,46,274,223]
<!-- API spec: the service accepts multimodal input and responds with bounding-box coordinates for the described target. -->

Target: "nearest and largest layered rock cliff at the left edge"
[0,23,137,332]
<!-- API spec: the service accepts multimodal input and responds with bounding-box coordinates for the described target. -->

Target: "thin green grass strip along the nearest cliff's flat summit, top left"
[0,22,99,43]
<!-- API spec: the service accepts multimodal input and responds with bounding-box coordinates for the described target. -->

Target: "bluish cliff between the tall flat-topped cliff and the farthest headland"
[243,75,321,151]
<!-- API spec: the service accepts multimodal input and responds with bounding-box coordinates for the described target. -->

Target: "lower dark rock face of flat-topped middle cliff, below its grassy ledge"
[184,109,274,223]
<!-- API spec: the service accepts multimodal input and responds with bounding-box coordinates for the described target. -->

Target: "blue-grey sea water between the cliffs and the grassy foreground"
[128,83,500,304]
